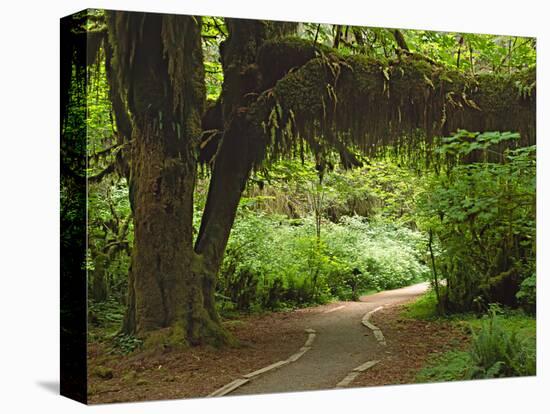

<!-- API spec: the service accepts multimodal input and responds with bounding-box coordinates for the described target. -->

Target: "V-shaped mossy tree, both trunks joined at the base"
[108,12,295,344]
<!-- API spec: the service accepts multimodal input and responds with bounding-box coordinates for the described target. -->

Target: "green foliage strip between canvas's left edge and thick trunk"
[83,42,133,303]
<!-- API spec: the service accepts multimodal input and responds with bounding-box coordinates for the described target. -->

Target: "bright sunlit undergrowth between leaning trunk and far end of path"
[218,211,427,309]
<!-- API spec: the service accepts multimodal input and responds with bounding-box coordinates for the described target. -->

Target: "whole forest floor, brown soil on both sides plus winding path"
[89,284,469,403]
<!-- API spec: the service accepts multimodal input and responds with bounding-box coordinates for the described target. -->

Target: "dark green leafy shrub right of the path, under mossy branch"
[417,131,536,311]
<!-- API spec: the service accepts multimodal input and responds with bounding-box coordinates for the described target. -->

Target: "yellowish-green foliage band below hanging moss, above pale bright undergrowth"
[248,159,421,226]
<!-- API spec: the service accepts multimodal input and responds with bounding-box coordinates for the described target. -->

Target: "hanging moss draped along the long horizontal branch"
[249,45,535,167]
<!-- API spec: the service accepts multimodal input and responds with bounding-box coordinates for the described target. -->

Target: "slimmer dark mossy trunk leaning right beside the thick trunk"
[195,19,297,324]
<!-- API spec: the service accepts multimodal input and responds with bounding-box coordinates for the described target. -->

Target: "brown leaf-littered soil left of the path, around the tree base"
[88,312,307,404]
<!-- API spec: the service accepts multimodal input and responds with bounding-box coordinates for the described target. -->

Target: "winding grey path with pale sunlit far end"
[230,283,428,395]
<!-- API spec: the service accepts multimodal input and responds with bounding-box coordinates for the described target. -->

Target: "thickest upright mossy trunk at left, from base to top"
[109,12,225,346]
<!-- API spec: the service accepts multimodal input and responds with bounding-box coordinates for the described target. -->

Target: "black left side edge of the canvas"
[59,10,88,404]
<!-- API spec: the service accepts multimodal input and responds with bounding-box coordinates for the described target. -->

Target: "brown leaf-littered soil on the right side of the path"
[351,305,470,387]
